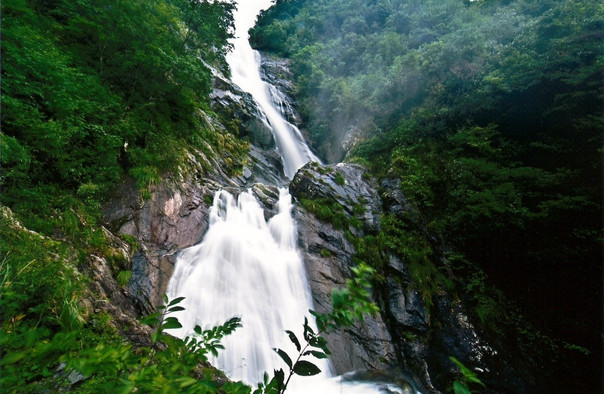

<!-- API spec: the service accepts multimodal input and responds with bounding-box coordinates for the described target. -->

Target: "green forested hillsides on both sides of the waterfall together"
[0,0,604,393]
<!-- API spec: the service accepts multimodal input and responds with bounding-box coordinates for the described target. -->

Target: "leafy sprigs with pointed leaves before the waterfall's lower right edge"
[254,263,379,394]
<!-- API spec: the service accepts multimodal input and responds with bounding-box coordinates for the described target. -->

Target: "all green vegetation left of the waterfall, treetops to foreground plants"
[0,0,247,392]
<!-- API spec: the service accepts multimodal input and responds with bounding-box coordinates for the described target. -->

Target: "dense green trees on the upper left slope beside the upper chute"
[1,0,240,209]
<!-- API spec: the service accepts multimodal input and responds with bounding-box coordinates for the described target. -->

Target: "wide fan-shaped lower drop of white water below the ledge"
[163,189,318,384]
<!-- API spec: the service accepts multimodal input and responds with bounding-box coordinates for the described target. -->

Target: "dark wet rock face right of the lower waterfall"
[290,164,531,393]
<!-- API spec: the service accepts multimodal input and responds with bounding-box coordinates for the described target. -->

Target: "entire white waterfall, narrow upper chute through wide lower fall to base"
[167,0,408,393]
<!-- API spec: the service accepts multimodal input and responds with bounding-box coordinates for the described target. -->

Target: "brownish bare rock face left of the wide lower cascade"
[104,180,218,313]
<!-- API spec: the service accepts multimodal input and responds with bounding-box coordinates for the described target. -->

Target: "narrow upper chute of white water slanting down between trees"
[227,0,319,179]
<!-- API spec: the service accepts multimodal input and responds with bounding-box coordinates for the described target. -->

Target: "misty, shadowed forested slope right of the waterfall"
[252,0,604,392]
